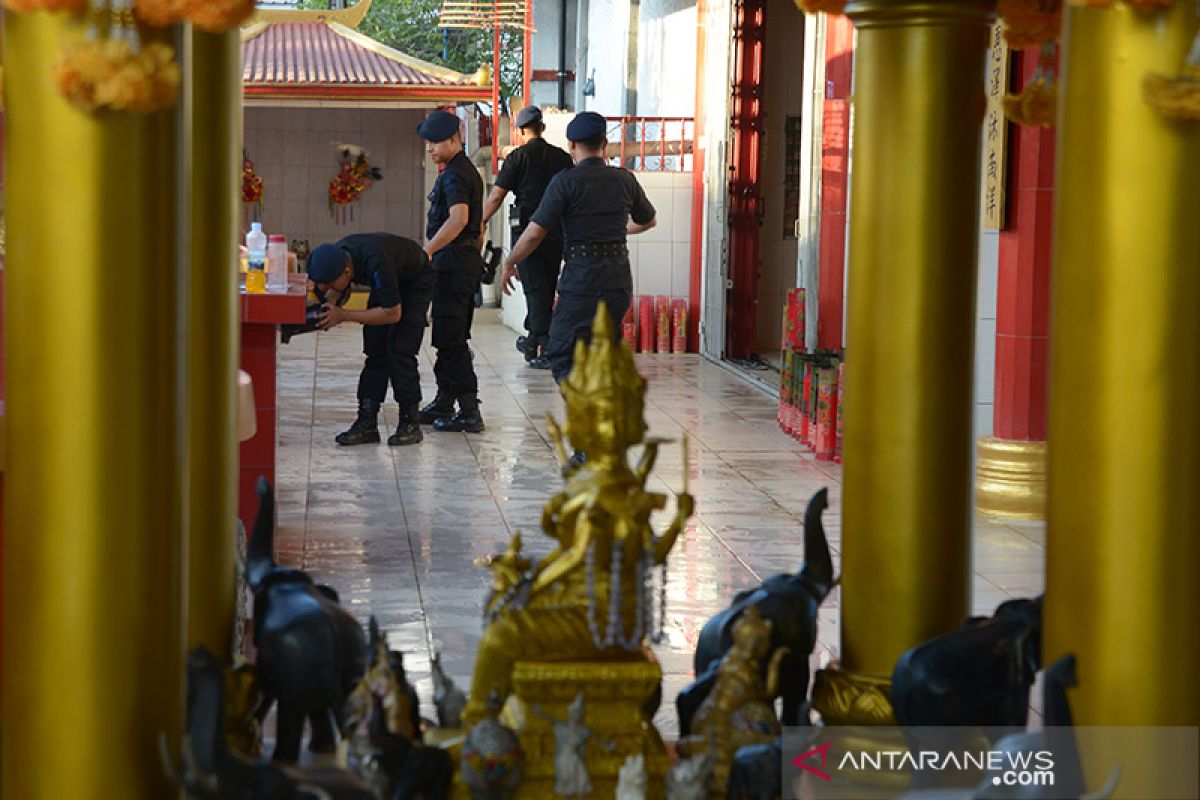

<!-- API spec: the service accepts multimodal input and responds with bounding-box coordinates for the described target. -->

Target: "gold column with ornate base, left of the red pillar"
[814,0,994,722]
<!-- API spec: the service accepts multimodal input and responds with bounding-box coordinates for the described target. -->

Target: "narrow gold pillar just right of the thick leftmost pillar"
[185,30,241,660]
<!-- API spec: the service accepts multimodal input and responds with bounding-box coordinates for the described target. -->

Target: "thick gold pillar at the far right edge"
[1045,1,1200,796]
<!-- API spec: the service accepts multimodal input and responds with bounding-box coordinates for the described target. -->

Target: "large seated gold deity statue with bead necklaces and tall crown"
[463,302,694,727]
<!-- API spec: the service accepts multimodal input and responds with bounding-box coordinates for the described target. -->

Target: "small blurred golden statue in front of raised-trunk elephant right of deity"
[678,606,788,796]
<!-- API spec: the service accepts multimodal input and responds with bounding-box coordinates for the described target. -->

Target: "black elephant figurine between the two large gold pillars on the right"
[892,597,1042,741]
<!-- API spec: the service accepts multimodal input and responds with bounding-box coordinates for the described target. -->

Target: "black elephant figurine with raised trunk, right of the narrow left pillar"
[246,479,367,763]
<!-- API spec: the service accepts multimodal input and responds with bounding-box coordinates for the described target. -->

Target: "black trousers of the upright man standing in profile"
[432,245,484,399]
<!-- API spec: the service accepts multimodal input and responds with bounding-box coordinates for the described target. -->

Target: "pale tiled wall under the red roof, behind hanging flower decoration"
[244,107,427,247]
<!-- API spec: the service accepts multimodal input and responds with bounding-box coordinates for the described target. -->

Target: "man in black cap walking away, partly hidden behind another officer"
[484,106,571,369]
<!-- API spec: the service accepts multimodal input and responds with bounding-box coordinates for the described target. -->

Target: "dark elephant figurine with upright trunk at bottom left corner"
[161,648,378,800]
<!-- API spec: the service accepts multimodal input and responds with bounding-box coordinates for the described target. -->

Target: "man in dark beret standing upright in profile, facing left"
[416,112,484,433]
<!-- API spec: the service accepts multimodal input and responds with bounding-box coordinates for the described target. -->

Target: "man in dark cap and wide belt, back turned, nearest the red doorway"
[504,112,656,381]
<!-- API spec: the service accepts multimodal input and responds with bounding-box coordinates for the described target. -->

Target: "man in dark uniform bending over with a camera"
[306,234,433,445]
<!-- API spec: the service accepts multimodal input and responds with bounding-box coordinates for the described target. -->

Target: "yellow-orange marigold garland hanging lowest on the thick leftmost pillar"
[54,38,180,113]
